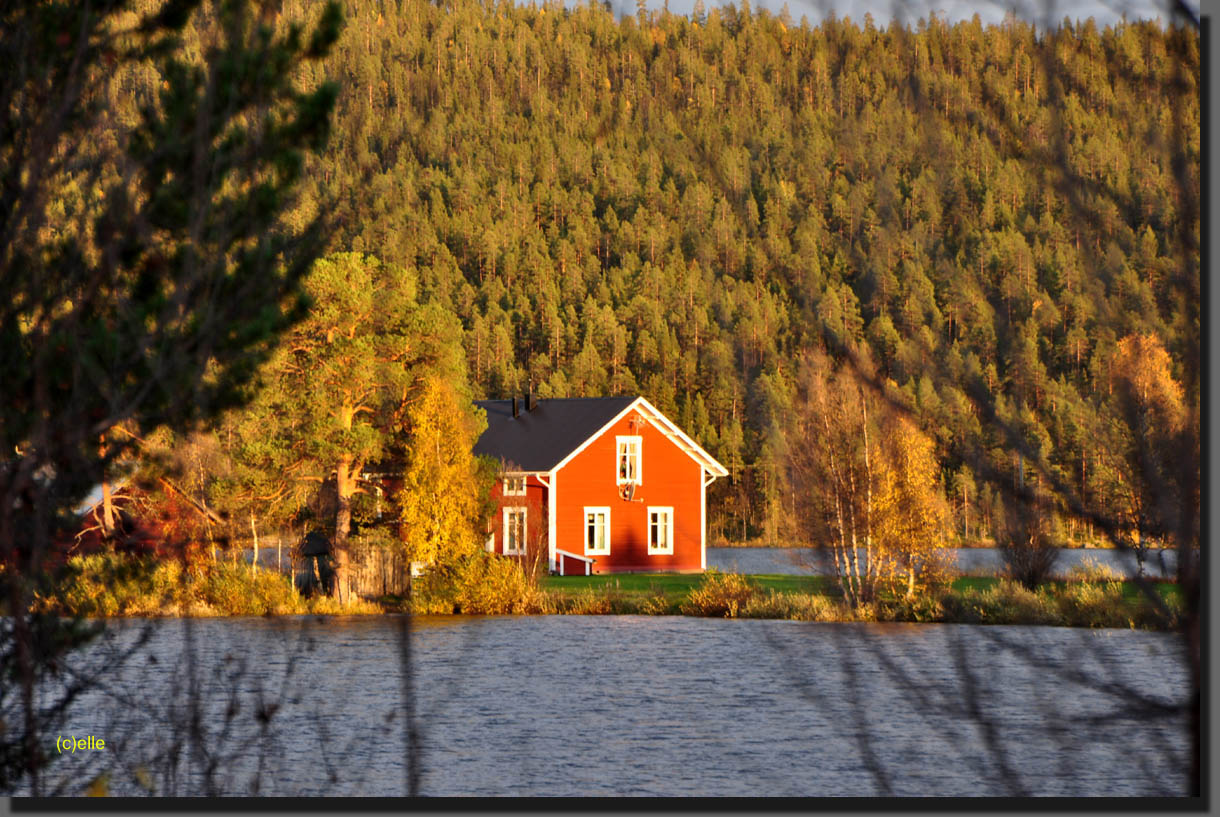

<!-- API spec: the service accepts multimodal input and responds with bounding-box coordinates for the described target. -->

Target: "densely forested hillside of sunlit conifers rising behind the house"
[97,0,1199,551]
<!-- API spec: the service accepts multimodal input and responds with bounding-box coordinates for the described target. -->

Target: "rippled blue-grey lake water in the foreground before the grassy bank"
[40,616,1187,796]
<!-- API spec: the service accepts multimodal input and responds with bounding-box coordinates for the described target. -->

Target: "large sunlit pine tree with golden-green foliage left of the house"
[229,252,477,601]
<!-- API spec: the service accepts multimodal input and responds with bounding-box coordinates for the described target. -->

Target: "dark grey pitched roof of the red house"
[475,398,637,471]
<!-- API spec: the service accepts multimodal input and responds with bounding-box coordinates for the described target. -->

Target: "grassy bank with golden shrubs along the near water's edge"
[45,554,1181,629]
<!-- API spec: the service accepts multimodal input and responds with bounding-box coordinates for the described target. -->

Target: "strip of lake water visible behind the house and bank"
[708,548,1177,577]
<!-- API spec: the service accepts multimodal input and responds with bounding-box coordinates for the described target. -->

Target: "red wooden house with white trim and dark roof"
[475,398,728,576]
